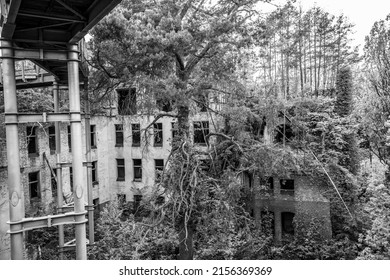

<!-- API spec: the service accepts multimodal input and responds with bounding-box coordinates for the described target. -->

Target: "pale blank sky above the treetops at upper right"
[264,0,390,50]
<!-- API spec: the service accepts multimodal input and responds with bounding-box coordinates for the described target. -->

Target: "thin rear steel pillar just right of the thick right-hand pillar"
[84,81,95,244]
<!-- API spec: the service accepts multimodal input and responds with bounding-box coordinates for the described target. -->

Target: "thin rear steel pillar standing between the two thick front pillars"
[53,81,65,259]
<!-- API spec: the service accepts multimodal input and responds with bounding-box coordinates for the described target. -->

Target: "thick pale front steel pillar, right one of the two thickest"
[68,44,87,260]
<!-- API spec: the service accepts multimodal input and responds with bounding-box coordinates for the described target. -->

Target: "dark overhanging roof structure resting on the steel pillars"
[0,0,121,85]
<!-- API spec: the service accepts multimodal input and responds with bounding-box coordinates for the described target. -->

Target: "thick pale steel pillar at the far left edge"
[1,39,24,260]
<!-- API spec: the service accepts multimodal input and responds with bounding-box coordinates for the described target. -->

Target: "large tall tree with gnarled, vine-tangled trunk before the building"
[91,0,261,259]
